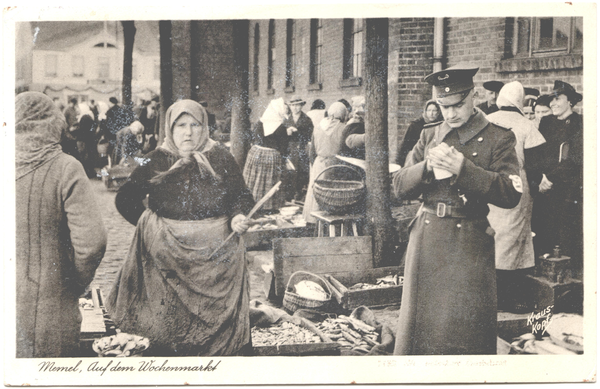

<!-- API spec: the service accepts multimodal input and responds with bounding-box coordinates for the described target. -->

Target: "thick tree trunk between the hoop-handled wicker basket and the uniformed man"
[365,18,397,267]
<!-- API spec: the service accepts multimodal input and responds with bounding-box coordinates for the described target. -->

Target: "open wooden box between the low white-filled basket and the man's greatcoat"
[324,266,404,311]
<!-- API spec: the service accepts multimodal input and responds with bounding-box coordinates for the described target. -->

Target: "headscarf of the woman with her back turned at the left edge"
[15,92,67,179]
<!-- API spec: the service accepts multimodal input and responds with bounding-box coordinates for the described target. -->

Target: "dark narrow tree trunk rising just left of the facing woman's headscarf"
[158,20,173,145]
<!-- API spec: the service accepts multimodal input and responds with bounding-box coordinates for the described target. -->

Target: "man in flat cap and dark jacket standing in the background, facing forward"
[284,96,313,200]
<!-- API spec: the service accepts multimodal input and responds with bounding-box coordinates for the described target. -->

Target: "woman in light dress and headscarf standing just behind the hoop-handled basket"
[302,102,348,223]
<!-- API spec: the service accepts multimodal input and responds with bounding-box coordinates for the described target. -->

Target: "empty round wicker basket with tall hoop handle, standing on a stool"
[313,165,367,215]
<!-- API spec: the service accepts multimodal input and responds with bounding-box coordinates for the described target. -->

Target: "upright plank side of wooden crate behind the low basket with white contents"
[273,236,373,297]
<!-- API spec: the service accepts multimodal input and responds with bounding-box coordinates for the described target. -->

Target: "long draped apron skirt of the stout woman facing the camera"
[106,210,250,356]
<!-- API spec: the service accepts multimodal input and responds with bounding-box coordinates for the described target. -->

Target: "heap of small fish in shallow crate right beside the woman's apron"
[251,321,321,347]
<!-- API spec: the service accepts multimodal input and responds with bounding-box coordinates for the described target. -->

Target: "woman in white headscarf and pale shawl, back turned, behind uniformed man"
[488,81,545,312]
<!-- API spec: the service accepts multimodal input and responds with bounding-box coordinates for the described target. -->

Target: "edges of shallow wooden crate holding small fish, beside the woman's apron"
[252,318,340,357]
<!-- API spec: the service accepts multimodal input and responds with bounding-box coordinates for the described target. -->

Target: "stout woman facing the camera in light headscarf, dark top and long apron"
[107,100,254,356]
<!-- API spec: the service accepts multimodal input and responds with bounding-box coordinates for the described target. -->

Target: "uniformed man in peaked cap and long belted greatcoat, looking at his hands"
[393,66,522,355]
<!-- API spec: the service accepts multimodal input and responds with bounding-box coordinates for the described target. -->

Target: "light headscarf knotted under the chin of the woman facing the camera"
[160,100,217,177]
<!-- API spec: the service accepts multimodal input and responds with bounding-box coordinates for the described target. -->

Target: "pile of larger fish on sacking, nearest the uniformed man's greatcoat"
[316,315,380,354]
